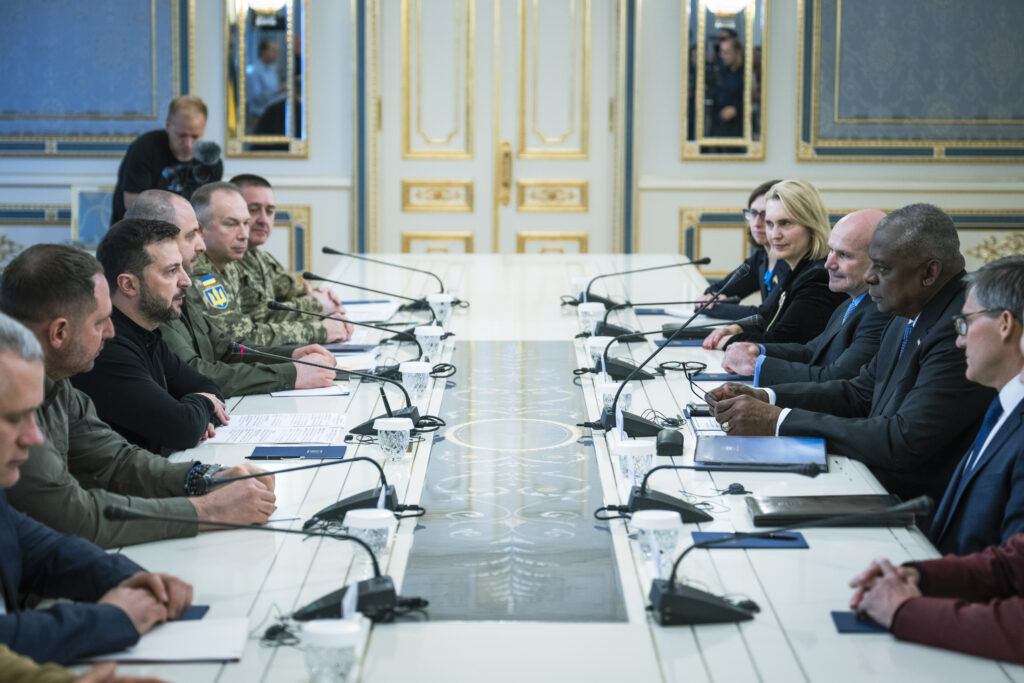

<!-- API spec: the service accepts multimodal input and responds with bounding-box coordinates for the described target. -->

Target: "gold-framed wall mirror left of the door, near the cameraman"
[224,0,308,157]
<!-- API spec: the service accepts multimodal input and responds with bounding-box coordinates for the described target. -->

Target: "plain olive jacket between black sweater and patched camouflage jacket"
[160,297,295,396]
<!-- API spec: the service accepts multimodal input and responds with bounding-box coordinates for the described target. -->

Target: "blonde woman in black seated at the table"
[703,180,845,349]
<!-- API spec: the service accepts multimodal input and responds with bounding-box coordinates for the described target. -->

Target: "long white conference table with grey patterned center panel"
[112,254,1024,683]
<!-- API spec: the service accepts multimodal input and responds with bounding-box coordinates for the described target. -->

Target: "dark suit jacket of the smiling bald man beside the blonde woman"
[758,294,892,386]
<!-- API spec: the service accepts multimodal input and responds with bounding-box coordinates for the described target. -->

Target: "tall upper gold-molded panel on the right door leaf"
[516,0,591,159]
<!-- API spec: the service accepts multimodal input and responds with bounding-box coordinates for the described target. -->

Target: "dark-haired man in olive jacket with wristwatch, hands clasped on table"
[0,245,274,548]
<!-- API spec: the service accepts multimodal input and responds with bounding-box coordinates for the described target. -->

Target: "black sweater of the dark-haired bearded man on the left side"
[71,307,221,455]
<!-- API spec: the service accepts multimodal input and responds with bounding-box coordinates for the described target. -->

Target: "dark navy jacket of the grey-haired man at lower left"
[0,492,142,664]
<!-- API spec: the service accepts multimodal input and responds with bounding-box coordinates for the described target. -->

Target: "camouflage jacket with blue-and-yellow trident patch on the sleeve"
[185,254,327,346]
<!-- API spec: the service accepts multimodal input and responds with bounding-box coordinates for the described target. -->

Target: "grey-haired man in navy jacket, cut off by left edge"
[0,314,191,663]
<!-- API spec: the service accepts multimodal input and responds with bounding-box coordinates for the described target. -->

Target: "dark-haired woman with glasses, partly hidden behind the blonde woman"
[693,180,790,321]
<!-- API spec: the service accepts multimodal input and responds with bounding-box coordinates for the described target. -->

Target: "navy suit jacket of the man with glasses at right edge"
[929,397,1024,555]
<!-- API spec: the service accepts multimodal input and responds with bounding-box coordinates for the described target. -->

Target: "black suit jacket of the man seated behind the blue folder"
[774,272,995,500]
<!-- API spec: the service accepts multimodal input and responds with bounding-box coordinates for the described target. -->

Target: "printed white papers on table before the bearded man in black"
[207,413,342,444]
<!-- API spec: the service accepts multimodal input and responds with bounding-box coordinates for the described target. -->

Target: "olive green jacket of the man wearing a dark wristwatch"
[7,378,199,548]
